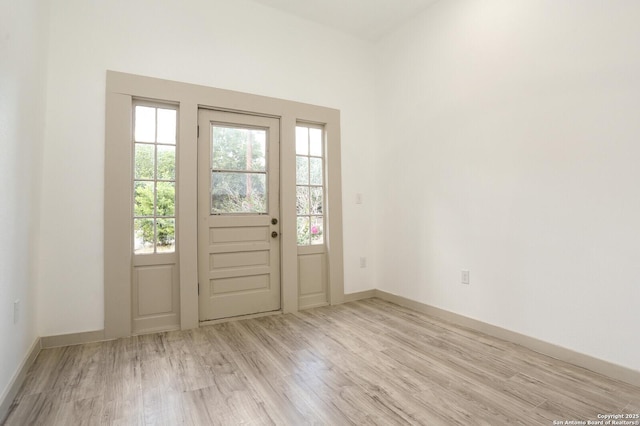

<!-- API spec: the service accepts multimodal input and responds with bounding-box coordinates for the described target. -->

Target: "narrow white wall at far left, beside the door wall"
[0,0,46,406]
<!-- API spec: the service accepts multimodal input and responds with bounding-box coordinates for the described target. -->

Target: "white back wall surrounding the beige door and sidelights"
[39,0,375,335]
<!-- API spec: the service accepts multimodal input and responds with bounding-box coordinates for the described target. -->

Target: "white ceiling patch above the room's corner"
[248,0,437,41]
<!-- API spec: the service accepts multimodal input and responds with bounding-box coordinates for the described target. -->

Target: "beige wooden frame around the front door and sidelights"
[104,71,344,338]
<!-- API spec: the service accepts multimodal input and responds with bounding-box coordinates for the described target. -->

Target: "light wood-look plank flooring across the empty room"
[5,299,640,426]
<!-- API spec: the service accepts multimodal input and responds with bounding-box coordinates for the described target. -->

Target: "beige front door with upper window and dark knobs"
[198,109,280,321]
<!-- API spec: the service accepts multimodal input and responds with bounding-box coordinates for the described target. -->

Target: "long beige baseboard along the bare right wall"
[372,290,640,386]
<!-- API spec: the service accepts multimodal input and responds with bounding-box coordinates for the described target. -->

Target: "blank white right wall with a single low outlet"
[375,0,640,370]
